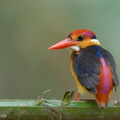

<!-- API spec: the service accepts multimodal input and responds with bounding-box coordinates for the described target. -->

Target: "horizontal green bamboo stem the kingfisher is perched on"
[0,99,120,120]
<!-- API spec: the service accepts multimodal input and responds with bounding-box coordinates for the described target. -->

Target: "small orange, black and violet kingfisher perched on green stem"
[48,29,119,108]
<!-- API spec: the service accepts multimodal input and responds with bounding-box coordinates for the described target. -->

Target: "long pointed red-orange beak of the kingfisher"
[48,38,76,49]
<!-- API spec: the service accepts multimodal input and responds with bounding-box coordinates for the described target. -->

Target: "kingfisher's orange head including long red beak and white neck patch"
[48,29,100,51]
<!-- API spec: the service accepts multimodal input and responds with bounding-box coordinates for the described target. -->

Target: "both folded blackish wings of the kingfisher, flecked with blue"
[73,46,119,94]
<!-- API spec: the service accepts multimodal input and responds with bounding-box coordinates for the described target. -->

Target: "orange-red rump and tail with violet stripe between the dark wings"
[95,58,113,107]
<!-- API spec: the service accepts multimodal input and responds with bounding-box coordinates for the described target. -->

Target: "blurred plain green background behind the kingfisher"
[0,0,120,99]
